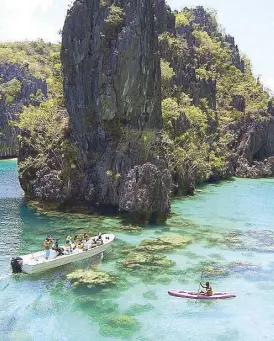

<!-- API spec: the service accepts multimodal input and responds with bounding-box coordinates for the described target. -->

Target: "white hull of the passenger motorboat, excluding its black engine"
[19,234,115,274]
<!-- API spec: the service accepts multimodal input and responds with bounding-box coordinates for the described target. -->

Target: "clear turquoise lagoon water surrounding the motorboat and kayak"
[0,161,274,341]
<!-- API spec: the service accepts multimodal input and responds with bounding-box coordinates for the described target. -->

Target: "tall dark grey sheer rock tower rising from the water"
[61,0,171,220]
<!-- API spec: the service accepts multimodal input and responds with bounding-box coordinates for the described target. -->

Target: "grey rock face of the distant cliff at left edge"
[0,63,47,159]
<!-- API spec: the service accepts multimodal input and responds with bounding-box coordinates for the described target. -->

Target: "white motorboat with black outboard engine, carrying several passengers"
[11,234,115,274]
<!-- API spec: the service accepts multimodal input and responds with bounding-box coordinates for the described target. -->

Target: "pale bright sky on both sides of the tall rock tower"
[0,0,274,91]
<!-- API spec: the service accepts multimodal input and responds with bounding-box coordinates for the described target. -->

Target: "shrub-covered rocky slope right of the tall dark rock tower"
[156,7,270,194]
